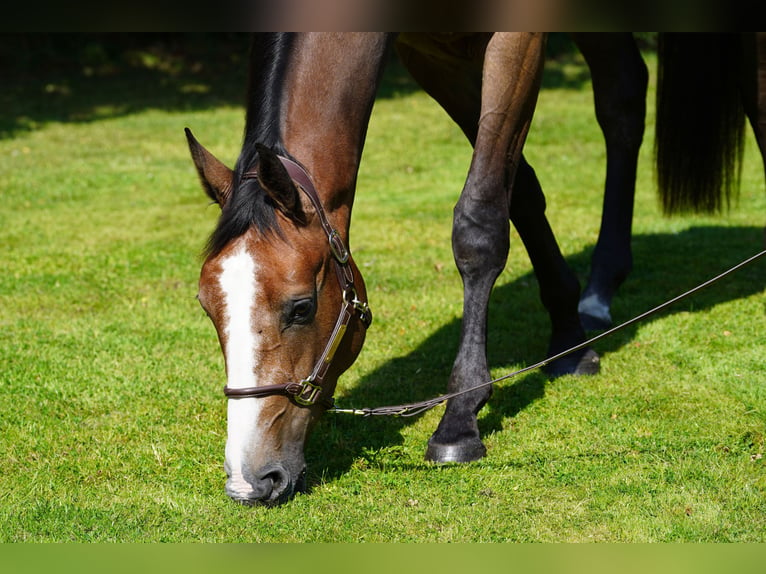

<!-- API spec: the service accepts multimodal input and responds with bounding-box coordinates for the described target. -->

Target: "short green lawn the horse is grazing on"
[0,42,766,542]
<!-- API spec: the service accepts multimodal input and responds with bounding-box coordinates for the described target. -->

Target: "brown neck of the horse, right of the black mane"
[281,33,389,240]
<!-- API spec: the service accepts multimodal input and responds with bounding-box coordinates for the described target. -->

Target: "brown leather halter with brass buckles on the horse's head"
[223,156,372,408]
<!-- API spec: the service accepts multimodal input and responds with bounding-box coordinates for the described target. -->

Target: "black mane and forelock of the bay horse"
[205,33,293,256]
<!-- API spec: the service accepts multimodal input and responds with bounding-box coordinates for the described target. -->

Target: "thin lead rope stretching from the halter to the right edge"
[328,249,766,417]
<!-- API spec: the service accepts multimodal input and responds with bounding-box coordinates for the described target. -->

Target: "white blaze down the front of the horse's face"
[219,248,262,494]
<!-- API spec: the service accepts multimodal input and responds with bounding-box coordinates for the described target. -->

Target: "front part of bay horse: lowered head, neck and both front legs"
[186,33,599,505]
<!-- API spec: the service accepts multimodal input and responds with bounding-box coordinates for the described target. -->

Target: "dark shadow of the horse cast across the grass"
[306,227,766,482]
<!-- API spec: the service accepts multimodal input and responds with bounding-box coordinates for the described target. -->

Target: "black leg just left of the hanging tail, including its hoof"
[572,33,648,330]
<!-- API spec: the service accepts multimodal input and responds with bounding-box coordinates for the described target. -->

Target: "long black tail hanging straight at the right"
[654,34,745,214]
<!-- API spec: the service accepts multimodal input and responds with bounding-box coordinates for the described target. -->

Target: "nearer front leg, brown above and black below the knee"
[425,33,544,462]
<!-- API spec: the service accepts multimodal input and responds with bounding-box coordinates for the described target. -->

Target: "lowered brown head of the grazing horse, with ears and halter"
[187,130,369,504]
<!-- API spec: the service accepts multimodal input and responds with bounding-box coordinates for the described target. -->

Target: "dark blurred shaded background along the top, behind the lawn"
[0,32,655,138]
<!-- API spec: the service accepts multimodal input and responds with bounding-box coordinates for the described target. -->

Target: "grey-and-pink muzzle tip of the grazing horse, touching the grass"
[226,463,306,506]
